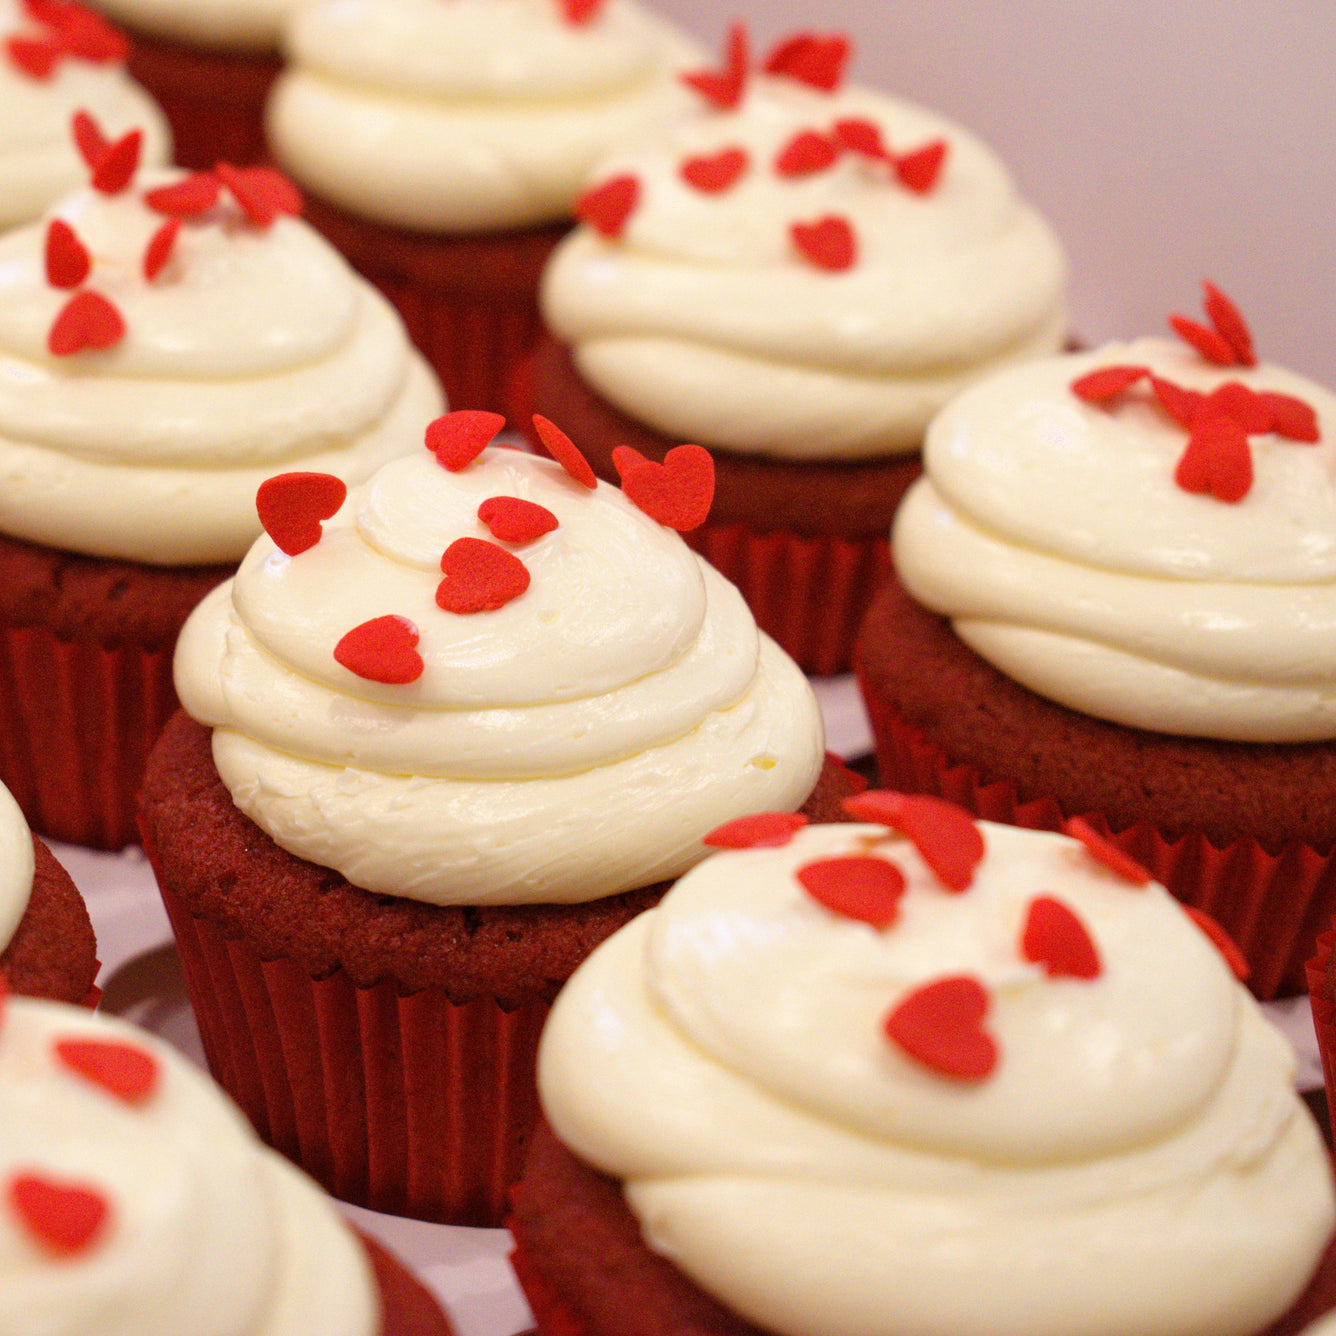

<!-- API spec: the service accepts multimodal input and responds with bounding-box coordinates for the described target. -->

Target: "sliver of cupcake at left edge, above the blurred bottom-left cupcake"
[0,784,99,1006]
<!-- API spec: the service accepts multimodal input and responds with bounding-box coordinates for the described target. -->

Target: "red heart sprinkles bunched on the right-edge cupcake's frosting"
[1071,282,1319,504]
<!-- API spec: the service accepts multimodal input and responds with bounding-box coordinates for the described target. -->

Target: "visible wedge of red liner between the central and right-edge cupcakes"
[683,524,891,677]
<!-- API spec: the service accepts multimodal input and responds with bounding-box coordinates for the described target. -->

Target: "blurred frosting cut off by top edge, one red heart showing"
[260,0,699,232]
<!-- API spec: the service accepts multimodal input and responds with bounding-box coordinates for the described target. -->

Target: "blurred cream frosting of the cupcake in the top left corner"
[0,0,171,230]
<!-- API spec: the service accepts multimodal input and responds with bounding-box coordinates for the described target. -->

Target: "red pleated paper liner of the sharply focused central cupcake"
[154,887,548,1225]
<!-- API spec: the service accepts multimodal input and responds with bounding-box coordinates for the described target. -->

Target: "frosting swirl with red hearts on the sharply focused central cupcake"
[176,424,823,904]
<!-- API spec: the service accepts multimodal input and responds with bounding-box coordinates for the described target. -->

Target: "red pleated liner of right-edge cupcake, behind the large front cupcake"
[860,681,1336,999]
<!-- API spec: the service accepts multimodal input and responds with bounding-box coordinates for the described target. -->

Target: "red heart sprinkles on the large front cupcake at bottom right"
[704,790,1248,1082]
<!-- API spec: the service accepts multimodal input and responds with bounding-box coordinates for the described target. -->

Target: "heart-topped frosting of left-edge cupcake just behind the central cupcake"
[0,115,441,565]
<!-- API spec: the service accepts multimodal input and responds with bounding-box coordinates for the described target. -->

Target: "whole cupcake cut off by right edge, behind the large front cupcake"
[856,285,1336,997]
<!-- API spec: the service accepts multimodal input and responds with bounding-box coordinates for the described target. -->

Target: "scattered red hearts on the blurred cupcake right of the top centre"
[576,24,947,271]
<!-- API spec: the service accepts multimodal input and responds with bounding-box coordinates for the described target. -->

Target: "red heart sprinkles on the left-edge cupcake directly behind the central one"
[44,111,302,357]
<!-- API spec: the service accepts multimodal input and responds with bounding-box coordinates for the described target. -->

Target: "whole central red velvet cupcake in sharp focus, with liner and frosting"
[142,410,850,1224]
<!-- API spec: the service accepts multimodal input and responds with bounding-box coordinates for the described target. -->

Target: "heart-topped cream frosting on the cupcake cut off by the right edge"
[892,285,1336,743]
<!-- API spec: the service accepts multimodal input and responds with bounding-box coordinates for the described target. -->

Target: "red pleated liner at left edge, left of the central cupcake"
[0,624,176,848]
